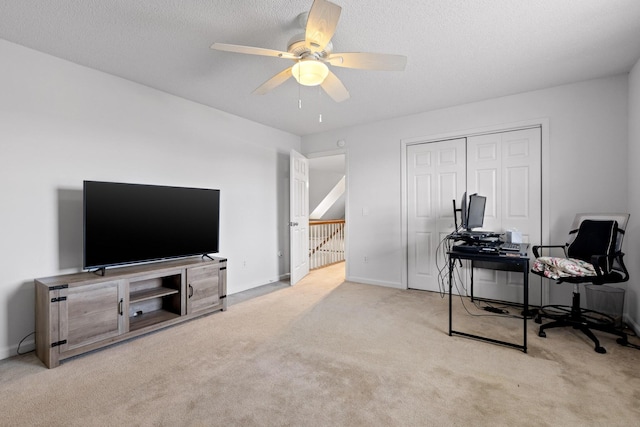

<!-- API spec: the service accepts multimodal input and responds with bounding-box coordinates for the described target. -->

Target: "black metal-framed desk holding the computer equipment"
[448,251,529,353]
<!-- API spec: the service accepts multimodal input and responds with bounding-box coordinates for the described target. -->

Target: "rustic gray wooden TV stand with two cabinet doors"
[35,257,227,368]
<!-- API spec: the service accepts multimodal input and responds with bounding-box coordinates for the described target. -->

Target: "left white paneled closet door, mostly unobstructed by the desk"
[407,138,466,291]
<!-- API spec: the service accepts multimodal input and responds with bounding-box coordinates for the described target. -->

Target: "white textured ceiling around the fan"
[0,0,640,135]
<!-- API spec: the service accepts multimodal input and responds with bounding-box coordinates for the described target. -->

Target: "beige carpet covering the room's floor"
[0,264,640,426]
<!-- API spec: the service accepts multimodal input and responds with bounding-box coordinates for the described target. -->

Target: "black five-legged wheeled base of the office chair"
[535,292,629,354]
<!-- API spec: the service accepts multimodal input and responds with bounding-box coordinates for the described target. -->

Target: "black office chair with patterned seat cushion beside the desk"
[531,214,629,353]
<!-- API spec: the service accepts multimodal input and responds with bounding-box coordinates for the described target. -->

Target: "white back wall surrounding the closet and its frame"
[302,75,629,303]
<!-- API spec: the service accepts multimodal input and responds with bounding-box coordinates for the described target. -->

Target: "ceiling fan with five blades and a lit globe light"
[211,0,407,102]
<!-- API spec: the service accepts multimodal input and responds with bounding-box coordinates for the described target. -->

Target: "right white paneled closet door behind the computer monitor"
[467,128,542,304]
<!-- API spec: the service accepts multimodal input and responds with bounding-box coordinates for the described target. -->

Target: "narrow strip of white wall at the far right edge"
[625,56,640,331]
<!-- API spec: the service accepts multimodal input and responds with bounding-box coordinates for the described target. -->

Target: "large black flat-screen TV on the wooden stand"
[83,181,220,269]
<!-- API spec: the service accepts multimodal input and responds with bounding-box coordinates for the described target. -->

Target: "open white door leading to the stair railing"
[289,150,309,285]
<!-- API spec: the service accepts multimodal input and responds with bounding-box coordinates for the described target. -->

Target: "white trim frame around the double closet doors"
[400,117,550,305]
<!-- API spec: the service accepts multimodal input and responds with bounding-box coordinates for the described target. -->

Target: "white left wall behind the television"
[0,40,300,358]
